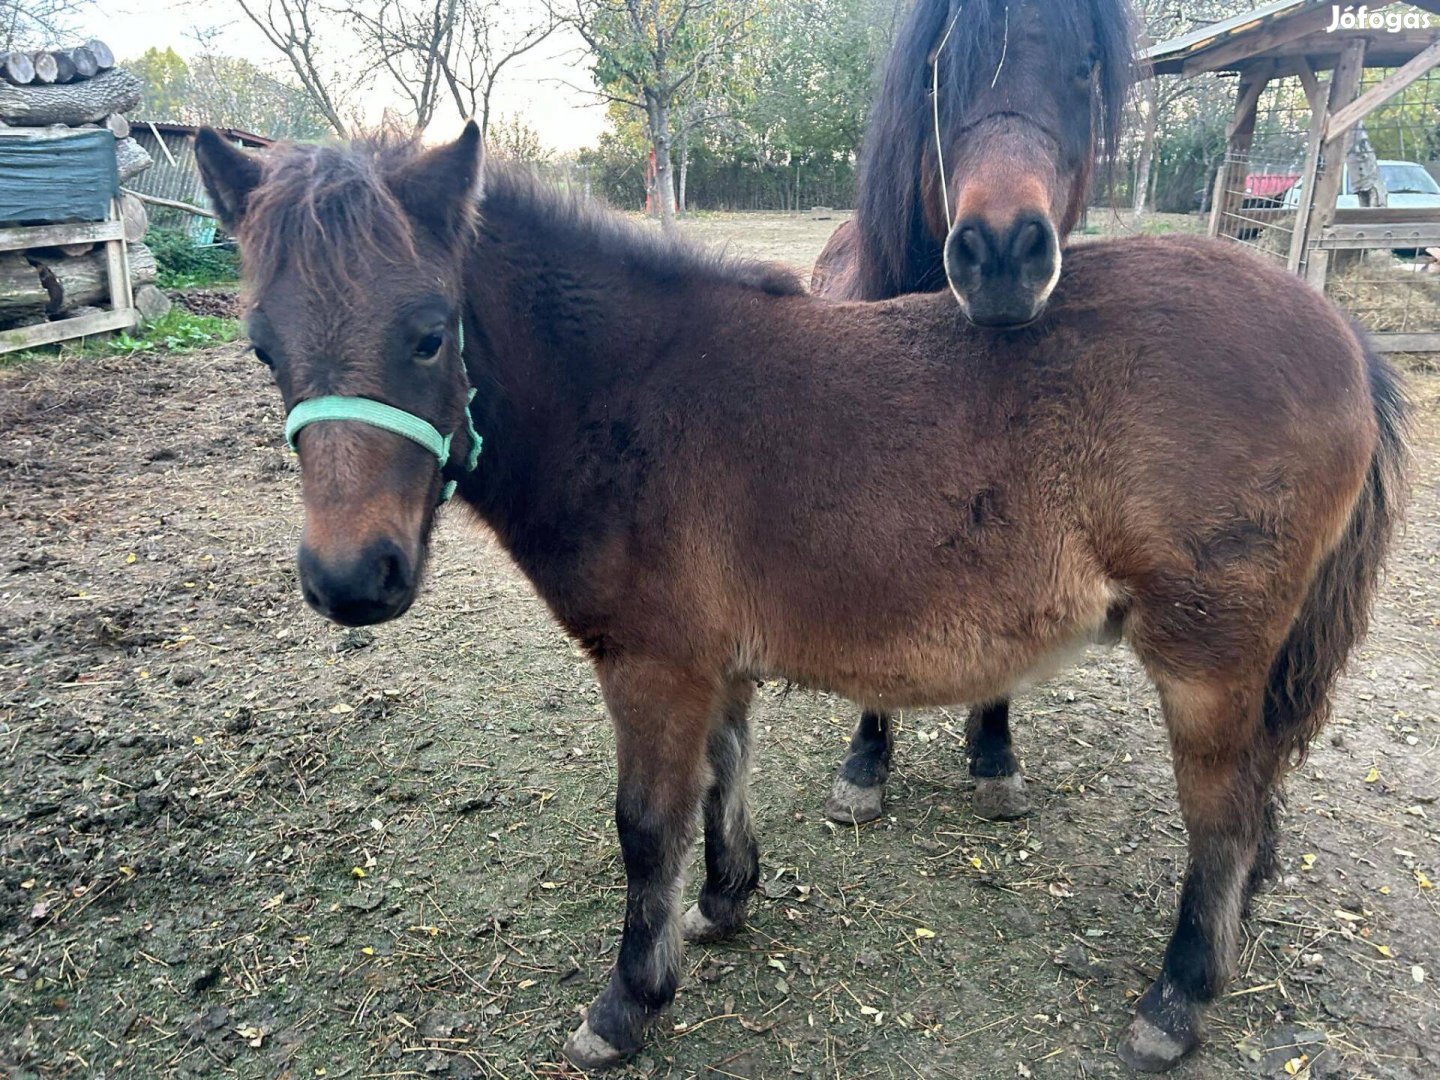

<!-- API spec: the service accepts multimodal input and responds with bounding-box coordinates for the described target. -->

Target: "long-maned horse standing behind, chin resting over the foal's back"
[812,0,1133,822]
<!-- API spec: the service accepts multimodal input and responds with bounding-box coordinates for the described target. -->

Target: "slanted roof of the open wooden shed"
[1142,0,1440,75]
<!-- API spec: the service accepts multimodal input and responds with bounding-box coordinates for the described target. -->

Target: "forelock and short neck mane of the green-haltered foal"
[239,135,805,305]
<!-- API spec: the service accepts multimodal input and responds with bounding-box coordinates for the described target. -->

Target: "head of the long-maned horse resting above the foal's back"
[922,0,1130,327]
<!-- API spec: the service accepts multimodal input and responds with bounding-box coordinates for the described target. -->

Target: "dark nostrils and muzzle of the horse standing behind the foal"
[945,212,1060,327]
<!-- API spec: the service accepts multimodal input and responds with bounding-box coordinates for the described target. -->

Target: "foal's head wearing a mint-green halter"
[196,124,481,626]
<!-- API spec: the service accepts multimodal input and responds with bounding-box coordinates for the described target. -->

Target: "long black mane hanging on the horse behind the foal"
[855,0,1133,298]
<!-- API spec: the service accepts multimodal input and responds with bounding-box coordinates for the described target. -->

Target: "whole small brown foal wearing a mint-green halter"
[197,125,1404,1068]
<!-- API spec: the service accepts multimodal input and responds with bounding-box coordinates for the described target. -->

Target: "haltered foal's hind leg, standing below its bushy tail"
[1119,678,1280,1071]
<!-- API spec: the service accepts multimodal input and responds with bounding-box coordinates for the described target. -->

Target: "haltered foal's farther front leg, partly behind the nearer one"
[681,680,760,942]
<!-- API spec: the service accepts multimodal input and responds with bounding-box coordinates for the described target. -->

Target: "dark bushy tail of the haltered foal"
[1264,334,1408,762]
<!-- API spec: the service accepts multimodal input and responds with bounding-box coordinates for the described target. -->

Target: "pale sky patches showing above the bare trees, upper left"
[76,0,605,151]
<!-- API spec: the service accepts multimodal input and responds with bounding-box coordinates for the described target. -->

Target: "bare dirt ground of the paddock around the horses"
[0,219,1440,1080]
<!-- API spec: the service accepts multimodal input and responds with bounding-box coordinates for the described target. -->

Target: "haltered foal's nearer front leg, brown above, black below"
[564,661,717,1068]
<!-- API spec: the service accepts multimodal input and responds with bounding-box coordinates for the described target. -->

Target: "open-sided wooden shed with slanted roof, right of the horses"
[1145,0,1440,351]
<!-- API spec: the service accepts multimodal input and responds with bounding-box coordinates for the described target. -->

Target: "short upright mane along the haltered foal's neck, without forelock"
[480,163,806,297]
